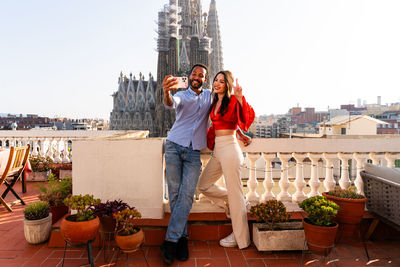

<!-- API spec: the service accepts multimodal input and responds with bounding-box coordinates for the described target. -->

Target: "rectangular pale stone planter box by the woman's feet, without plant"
[253,222,305,251]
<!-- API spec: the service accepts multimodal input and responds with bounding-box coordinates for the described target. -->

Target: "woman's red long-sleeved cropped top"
[207,95,255,150]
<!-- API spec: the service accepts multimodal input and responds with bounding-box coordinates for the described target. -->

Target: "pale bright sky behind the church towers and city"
[0,0,400,119]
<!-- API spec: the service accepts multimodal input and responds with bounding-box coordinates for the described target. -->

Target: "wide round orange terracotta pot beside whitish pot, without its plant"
[60,215,100,245]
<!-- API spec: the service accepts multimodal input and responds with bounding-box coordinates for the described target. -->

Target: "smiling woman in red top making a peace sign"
[198,71,254,249]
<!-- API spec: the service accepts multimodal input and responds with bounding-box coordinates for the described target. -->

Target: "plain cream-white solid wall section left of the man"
[72,139,164,218]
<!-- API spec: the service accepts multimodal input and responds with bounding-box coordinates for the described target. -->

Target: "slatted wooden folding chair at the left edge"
[0,144,30,211]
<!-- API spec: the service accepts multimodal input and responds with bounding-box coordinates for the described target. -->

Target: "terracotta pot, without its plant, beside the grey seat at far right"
[322,193,367,237]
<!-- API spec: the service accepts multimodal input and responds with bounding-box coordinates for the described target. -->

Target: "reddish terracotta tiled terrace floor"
[0,183,400,267]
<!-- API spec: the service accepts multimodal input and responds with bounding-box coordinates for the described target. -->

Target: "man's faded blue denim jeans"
[165,140,201,242]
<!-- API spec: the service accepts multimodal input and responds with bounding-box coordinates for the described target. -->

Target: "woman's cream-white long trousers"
[198,135,250,249]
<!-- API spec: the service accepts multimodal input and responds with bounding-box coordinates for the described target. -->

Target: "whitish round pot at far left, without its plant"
[24,213,52,244]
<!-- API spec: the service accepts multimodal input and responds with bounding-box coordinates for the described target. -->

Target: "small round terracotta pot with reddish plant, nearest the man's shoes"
[114,207,144,252]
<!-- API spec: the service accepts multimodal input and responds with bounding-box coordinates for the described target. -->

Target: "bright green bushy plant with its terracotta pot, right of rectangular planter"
[299,196,339,254]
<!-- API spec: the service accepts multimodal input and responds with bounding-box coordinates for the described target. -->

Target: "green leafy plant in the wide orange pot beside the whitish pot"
[64,195,100,222]
